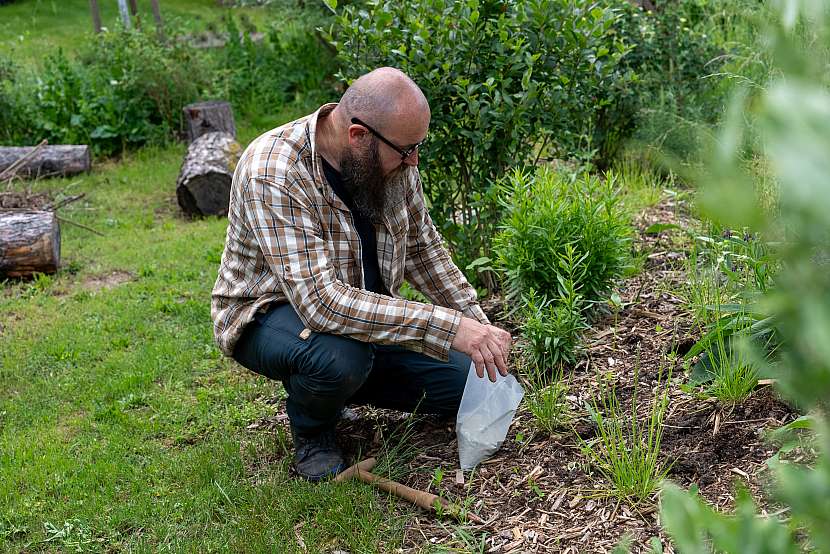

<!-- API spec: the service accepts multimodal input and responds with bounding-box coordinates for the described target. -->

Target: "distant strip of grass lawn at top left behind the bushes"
[0,0,285,64]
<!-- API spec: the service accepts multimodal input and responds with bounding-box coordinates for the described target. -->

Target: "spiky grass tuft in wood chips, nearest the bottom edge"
[579,363,671,504]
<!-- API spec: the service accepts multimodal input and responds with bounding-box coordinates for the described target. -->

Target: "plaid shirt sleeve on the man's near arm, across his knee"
[242,176,461,360]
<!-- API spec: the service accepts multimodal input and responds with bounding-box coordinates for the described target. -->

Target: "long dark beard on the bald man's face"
[340,140,403,223]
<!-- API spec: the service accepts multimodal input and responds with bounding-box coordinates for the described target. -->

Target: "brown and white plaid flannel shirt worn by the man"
[211,104,488,360]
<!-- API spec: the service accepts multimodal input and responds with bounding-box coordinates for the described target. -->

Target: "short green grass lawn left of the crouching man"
[0,112,412,552]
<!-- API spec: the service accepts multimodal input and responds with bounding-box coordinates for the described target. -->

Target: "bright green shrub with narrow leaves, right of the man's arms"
[493,168,631,303]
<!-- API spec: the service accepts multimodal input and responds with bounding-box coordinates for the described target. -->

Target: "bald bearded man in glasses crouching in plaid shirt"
[211,68,511,481]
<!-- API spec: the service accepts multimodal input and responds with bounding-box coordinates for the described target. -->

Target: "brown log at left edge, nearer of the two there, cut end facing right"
[0,210,61,278]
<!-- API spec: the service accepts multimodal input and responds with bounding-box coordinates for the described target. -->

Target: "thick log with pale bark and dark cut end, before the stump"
[176,133,242,215]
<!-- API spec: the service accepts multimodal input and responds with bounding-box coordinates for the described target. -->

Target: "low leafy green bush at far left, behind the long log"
[0,30,210,154]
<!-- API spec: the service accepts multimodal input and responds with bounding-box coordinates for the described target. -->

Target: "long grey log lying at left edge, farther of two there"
[0,144,90,177]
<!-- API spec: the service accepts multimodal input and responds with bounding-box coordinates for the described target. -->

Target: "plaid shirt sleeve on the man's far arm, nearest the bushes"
[405,171,490,324]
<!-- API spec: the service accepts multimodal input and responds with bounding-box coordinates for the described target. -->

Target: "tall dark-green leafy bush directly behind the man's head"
[329,0,628,277]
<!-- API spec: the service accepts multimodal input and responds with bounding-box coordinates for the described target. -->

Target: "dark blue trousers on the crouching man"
[233,303,471,435]
